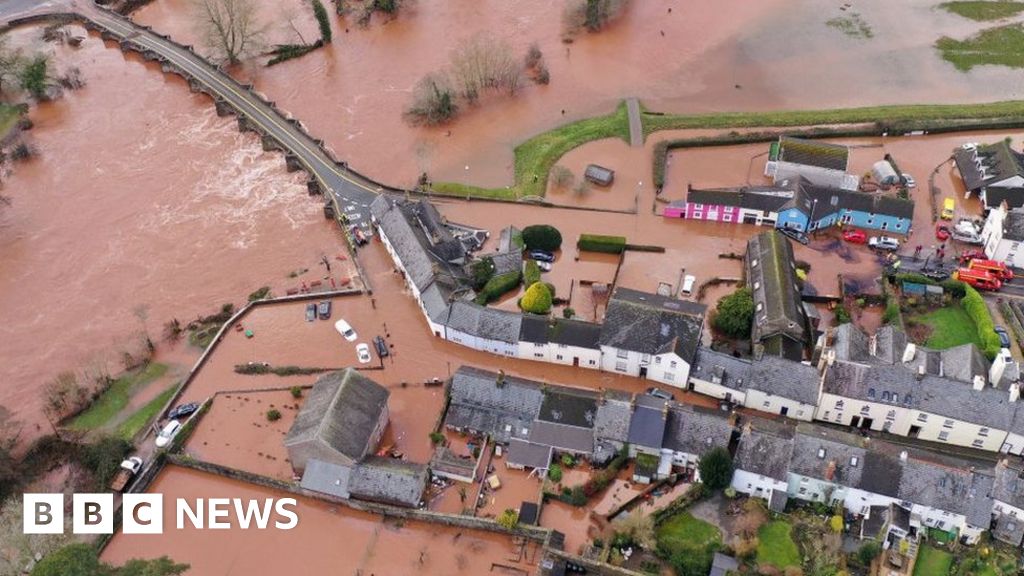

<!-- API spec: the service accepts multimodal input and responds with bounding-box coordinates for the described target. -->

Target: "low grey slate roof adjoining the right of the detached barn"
[348,456,429,507]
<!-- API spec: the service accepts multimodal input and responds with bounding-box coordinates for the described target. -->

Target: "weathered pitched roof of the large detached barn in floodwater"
[285,368,390,460]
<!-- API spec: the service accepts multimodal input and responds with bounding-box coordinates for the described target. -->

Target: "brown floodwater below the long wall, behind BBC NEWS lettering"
[102,466,537,576]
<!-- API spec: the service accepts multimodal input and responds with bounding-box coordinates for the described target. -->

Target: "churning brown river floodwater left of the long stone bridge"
[0,28,342,438]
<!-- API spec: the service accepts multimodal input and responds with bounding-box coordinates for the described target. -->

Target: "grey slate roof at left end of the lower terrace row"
[444,366,544,443]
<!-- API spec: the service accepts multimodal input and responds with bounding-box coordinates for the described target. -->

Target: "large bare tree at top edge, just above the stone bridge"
[194,0,265,65]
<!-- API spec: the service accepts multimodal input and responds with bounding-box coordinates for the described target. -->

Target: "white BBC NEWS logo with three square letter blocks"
[24,494,299,534]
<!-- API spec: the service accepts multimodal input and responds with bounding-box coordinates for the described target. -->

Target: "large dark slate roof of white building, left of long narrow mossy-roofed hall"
[599,288,708,363]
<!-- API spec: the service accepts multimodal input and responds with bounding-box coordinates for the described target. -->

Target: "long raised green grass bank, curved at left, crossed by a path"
[433,96,1024,200]
